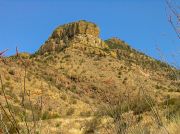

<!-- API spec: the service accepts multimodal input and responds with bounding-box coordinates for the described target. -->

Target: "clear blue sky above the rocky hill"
[0,0,180,66]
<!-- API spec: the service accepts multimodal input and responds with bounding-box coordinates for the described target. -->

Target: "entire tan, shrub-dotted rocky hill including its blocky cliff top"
[0,20,180,134]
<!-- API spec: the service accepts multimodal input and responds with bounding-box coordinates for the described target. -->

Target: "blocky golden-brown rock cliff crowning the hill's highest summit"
[39,20,107,54]
